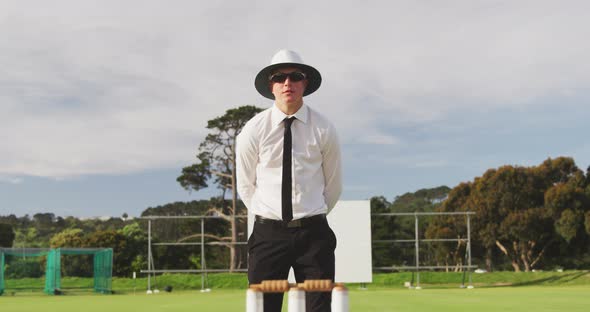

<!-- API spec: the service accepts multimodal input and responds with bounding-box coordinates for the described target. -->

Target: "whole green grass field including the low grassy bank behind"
[0,271,590,312]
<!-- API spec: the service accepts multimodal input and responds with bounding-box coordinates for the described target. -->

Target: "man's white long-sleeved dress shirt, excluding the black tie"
[236,104,342,220]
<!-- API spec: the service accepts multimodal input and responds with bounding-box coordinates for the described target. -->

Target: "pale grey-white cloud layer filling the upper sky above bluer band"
[0,1,590,177]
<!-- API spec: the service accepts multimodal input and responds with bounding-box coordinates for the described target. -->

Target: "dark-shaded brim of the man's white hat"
[254,63,322,100]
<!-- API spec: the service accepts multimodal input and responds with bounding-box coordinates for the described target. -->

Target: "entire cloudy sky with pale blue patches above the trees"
[0,0,590,217]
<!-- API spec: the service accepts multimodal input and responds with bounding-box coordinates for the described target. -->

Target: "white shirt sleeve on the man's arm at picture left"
[236,124,258,210]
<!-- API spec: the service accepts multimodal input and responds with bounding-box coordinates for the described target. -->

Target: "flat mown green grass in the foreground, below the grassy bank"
[0,286,590,312]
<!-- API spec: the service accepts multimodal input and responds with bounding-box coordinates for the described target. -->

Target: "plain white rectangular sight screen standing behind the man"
[248,200,373,283]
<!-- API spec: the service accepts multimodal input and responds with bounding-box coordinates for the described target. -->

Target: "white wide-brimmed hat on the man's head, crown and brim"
[254,50,322,100]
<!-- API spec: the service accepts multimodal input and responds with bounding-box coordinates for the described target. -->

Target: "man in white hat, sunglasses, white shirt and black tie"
[236,50,342,312]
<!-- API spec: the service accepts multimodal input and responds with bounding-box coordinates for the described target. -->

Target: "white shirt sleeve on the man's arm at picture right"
[322,126,342,213]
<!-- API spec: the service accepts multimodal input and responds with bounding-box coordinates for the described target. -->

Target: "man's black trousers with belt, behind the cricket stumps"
[248,219,336,312]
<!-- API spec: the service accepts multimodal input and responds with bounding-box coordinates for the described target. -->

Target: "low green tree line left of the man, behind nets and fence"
[0,198,246,278]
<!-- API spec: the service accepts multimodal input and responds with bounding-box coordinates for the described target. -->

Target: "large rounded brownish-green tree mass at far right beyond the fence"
[431,157,590,271]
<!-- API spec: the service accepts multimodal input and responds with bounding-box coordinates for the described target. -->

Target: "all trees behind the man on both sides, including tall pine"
[0,106,590,276]
